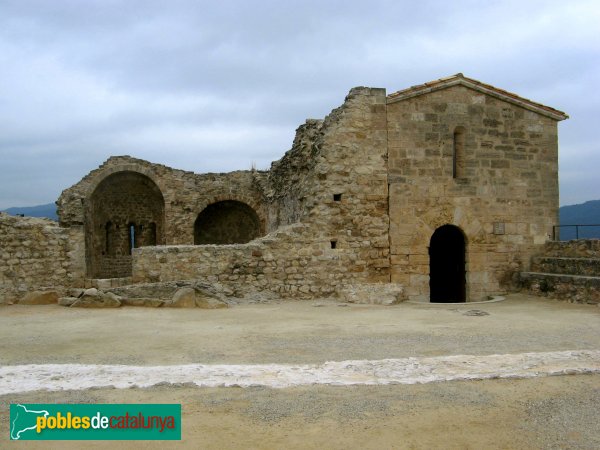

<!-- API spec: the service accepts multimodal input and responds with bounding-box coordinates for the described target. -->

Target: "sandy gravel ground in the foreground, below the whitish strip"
[0,375,600,450]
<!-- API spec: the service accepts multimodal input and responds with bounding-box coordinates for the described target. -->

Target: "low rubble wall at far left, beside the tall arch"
[0,213,85,303]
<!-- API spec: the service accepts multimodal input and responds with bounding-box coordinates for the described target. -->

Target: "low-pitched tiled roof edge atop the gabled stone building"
[387,73,569,120]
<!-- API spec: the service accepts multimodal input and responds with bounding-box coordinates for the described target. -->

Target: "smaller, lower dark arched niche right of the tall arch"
[194,200,262,245]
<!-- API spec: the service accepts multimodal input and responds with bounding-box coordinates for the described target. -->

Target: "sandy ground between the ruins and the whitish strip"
[0,295,600,365]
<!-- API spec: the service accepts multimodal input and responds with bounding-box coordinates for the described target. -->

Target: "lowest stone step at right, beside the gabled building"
[520,272,600,305]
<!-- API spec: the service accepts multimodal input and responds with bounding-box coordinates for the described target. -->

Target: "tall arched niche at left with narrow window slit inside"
[86,171,165,278]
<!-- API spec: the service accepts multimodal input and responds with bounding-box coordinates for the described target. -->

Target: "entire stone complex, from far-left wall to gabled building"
[0,74,568,304]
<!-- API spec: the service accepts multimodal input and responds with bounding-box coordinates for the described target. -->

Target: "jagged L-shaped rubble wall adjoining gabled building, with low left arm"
[133,88,390,297]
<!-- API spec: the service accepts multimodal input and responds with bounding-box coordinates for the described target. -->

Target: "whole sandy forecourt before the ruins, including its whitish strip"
[0,295,600,449]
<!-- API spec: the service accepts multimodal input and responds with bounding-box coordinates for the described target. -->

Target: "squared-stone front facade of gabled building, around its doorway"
[388,86,558,300]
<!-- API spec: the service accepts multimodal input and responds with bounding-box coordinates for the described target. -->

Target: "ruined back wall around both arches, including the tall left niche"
[57,156,268,278]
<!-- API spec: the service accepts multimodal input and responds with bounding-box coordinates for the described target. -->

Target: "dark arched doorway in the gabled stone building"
[429,225,466,303]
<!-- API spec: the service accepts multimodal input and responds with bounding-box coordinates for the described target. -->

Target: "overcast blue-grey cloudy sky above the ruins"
[0,0,600,209]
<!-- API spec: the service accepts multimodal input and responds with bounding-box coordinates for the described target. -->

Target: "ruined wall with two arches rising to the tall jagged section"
[57,88,389,282]
